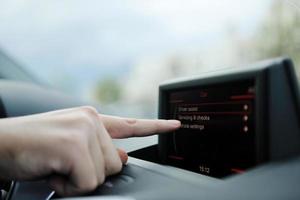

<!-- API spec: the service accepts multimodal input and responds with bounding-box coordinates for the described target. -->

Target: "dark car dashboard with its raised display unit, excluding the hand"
[0,58,300,200]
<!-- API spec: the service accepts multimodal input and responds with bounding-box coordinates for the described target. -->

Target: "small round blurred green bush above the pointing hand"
[94,78,121,104]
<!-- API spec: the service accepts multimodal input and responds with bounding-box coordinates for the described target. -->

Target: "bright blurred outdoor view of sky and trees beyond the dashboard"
[0,0,300,118]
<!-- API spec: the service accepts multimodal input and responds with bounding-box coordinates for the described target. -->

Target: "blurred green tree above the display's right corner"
[244,0,300,75]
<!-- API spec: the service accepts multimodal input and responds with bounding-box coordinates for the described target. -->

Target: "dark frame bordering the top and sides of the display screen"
[158,70,268,170]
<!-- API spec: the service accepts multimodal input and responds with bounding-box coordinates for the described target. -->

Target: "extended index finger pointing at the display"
[99,114,181,138]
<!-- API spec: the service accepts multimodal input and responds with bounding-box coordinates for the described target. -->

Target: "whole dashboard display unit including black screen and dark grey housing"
[158,58,300,178]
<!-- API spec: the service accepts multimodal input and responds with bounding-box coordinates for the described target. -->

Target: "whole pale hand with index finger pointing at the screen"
[0,106,180,196]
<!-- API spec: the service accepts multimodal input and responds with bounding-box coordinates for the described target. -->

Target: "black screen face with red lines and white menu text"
[166,80,255,177]
